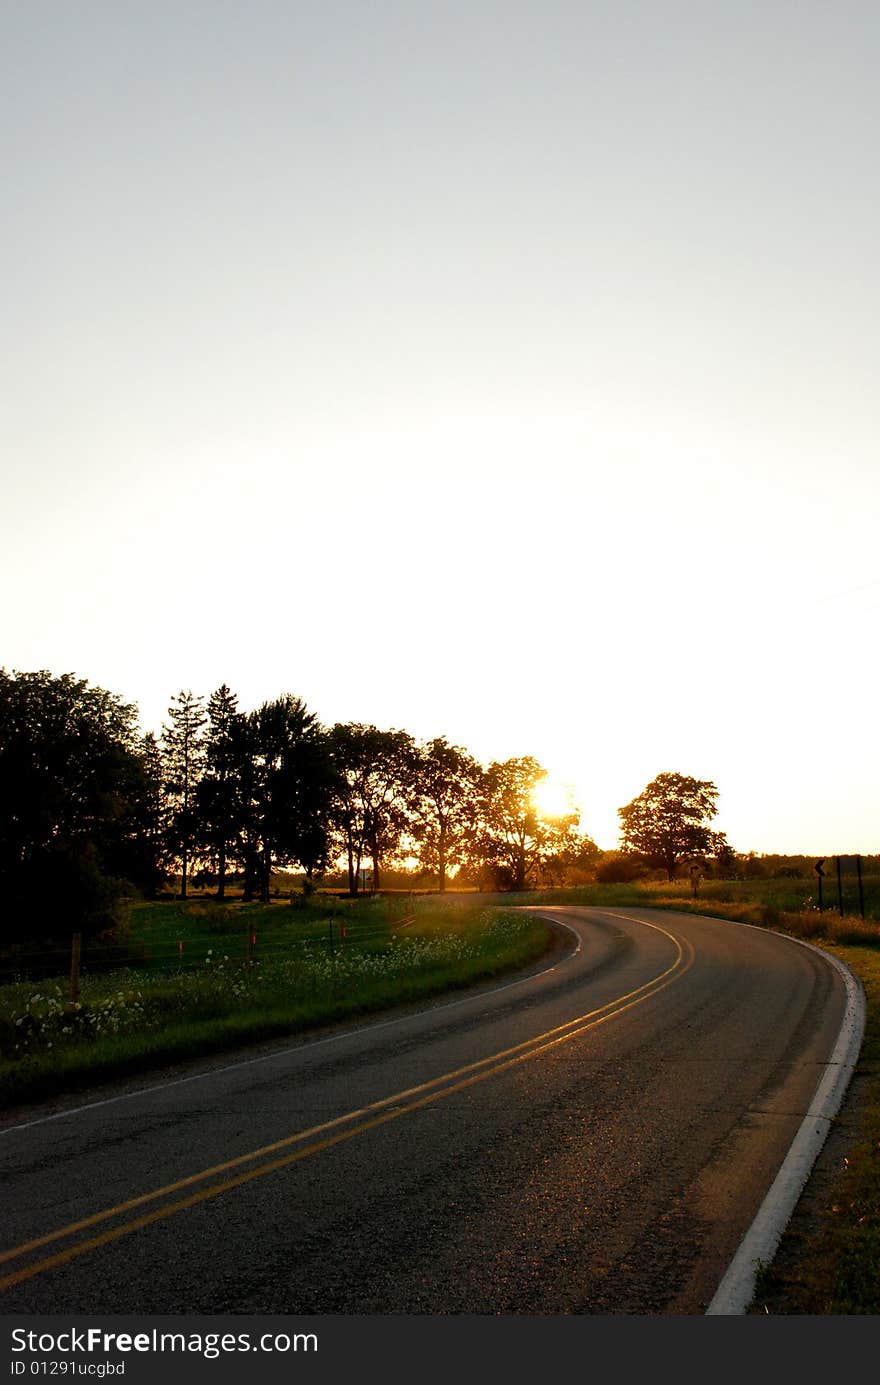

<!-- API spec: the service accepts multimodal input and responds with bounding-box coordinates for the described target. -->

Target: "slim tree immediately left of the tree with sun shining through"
[412,735,481,893]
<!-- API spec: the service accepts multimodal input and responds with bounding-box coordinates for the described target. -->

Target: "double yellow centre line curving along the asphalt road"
[0,920,693,1291]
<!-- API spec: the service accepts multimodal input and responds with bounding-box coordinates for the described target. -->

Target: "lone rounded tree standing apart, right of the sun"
[617,774,726,879]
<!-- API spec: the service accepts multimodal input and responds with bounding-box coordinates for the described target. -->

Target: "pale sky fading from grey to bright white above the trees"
[0,0,880,856]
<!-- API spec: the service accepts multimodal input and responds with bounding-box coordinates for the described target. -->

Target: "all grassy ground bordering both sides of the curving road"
[0,877,880,1316]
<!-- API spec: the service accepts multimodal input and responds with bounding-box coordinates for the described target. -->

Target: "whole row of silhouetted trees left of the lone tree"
[0,670,601,938]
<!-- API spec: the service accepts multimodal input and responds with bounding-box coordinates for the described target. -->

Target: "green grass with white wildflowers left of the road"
[0,899,550,1105]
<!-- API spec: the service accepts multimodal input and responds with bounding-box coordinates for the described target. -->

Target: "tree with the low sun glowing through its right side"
[474,755,578,891]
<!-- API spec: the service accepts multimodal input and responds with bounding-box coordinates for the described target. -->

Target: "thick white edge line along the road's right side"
[705,924,865,1317]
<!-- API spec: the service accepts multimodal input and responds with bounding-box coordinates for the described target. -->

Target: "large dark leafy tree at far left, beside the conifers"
[0,669,144,939]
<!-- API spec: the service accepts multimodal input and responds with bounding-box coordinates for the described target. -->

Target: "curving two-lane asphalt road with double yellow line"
[0,907,844,1314]
